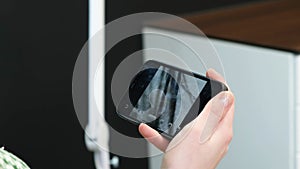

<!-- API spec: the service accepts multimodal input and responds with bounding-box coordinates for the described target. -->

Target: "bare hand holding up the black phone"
[139,69,234,169]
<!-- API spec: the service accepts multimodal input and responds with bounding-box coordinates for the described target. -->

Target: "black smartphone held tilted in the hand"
[117,60,228,139]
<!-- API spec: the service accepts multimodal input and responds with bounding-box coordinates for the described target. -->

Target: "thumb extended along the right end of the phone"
[200,92,233,144]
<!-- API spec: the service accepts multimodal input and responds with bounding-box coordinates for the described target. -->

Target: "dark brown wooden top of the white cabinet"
[146,0,300,52]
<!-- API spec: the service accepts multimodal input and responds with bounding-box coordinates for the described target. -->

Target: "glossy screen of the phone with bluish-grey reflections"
[130,66,206,136]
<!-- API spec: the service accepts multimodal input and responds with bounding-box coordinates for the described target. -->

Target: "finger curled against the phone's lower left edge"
[139,123,169,152]
